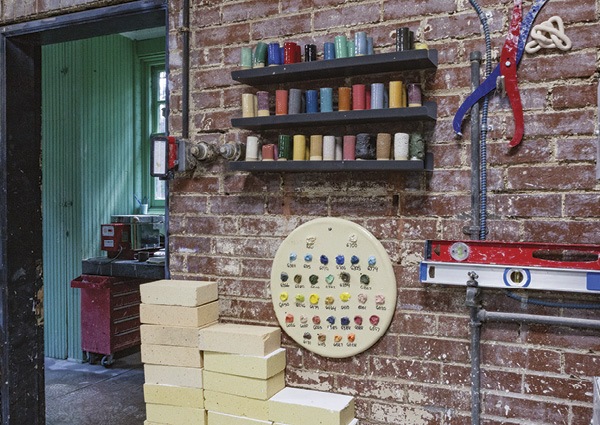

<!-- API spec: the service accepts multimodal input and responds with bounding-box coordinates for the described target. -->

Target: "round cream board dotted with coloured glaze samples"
[271,218,397,358]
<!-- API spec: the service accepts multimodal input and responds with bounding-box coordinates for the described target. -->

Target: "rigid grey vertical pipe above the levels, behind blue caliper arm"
[469,52,481,240]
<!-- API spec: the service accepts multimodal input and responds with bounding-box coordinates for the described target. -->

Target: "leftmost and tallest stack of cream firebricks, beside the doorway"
[140,280,219,425]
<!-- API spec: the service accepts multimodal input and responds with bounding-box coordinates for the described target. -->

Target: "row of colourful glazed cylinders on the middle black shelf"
[242,81,423,118]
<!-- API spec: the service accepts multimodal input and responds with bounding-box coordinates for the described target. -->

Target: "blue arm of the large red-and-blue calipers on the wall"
[452,0,548,136]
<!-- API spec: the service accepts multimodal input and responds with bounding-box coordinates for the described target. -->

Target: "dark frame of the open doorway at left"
[0,0,169,425]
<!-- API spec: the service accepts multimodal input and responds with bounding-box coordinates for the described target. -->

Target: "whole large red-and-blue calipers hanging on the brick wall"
[452,0,548,147]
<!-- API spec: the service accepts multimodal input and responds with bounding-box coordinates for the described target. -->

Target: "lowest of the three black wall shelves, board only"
[229,152,433,173]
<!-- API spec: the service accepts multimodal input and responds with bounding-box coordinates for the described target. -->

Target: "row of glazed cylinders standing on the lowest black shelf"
[241,133,425,161]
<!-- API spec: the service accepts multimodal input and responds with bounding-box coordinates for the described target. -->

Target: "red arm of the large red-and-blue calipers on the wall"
[500,0,523,147]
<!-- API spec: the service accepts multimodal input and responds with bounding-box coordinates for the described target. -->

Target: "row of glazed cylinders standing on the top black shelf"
[241,27,427,69]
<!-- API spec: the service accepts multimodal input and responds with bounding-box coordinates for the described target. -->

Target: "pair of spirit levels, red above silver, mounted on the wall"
[420,241,600,293]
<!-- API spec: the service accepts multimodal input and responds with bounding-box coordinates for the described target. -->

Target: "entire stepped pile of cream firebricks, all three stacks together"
[140,281,358,425]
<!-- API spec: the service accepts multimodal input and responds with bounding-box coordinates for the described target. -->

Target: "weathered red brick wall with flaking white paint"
[2,0,600,425]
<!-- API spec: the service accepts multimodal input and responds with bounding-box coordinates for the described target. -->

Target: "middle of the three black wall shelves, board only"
[231,102,437,130]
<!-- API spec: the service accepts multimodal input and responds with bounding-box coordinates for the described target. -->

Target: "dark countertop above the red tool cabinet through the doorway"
[81,257,165,279]
